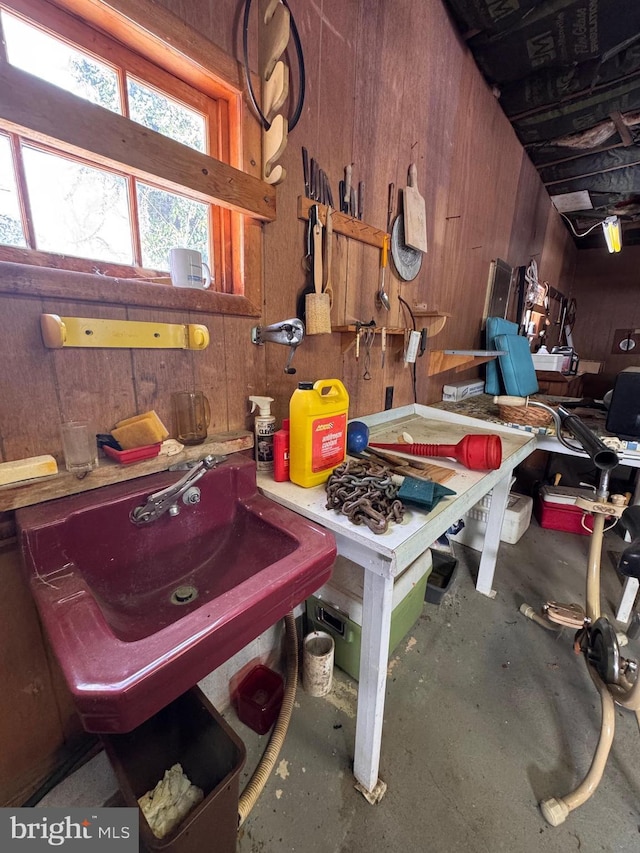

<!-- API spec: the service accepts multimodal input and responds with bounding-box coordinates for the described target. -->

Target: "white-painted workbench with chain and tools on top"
[258,405,536,802]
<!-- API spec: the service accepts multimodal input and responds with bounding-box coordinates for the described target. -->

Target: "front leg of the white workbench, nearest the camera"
[353,568,394,803]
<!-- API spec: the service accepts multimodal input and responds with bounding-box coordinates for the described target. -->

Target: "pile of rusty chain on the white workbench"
[326,460,404,533]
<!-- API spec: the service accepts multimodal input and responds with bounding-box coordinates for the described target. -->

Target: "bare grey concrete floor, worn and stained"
[42,520,640,853]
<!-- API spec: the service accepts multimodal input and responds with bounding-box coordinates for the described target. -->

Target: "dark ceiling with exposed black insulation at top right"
[444,0,640,248]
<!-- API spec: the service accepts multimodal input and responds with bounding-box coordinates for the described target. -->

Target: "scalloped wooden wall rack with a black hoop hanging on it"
[242,0,305,184]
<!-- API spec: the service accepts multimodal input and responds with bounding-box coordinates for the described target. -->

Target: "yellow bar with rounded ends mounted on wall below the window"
[40,314,209,349]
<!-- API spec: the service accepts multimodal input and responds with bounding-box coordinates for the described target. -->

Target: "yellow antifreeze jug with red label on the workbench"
[289,379,349,488]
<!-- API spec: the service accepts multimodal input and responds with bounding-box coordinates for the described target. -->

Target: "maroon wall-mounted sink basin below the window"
[16,457,336,733]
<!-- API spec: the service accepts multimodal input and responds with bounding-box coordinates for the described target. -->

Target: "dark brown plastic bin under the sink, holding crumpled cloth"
[102,687,246,853]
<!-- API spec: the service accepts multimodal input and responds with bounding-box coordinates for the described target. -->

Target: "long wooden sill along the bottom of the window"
[0,261,260,317]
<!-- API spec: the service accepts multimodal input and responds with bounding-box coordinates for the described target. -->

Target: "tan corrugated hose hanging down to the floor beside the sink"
[238,611,298,827]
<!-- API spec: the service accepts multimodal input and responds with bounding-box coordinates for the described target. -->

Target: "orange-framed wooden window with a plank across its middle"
[0,0,274,313]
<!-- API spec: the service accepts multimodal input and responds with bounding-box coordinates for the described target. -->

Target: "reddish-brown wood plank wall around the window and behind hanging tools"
[0,0,584,798]
